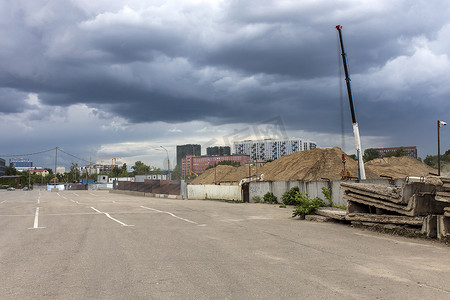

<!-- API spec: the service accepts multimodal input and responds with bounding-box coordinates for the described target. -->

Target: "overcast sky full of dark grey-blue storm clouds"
[0,0,450,168]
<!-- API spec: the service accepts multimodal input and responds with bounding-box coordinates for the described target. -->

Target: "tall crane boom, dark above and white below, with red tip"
[336,25,366,180]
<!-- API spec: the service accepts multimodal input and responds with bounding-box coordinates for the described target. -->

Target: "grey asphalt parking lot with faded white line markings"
[0,190,450,299]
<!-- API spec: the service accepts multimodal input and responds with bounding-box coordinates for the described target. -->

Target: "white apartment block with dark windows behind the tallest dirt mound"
[233,138,317,162]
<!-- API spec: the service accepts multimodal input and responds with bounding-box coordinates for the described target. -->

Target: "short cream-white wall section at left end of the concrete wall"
[187,184,241,200]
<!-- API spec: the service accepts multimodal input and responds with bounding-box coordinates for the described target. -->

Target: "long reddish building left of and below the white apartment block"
[181,155,250,176]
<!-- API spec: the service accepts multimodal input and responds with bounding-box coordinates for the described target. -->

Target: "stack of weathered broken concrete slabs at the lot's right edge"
[341,177,450,237]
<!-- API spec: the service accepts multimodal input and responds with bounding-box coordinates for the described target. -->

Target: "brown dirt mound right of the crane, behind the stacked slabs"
[365,156,437,178]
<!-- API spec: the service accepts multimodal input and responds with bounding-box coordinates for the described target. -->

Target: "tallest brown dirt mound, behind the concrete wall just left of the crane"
[262,147,380,181]
